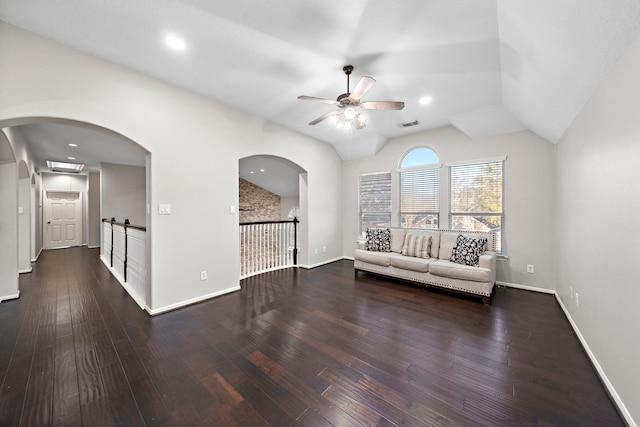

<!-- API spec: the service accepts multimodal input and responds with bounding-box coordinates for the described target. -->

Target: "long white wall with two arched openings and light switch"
[0,23,343,312]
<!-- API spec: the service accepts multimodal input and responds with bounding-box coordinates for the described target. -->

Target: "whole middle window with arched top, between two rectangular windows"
[399,147,440,228]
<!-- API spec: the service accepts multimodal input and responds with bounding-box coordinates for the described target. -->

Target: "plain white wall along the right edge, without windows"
[555,29,640,422]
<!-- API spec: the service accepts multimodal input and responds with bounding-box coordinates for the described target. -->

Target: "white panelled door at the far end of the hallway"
[43,191,82,249]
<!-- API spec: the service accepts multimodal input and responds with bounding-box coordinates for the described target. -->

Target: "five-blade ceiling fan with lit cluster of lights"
[298,65,404,129]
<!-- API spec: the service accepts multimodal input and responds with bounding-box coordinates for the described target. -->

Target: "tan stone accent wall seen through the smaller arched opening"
[239,178,281,222]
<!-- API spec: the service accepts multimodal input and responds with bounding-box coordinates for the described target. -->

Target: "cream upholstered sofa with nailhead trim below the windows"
[354,228,496,305]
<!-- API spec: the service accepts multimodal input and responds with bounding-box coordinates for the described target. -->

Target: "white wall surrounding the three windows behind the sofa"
[343,126,555,290]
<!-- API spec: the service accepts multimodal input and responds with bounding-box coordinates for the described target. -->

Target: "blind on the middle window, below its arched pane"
[400,167,440,228]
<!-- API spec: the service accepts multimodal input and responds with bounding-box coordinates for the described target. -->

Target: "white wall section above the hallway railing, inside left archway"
[100,163,147,227]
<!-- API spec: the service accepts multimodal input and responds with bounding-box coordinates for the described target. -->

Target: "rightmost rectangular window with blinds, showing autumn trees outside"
[449,160,505,252]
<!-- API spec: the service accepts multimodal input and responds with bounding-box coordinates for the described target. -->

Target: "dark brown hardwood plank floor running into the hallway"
[0,248,624,426]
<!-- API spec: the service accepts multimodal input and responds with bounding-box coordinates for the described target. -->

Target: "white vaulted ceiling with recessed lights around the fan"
[0,0,640,159]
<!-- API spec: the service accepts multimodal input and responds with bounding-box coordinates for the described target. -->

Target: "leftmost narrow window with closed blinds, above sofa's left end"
[358,172,391,237]
